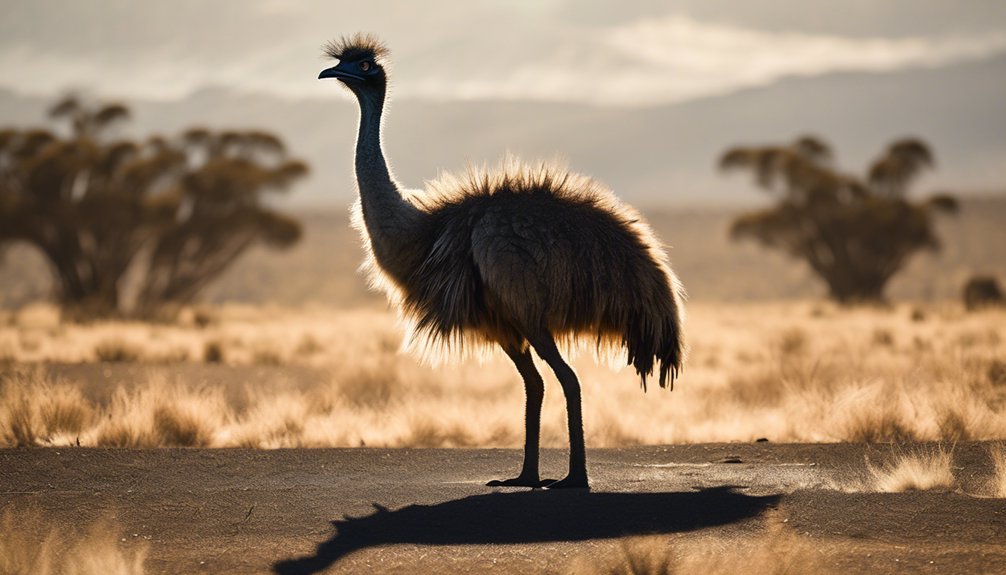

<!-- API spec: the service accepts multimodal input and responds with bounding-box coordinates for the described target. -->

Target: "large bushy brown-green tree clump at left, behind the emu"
[0,97,308,315]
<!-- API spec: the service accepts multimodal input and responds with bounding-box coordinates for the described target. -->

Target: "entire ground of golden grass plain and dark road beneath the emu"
[0,200,1006,574]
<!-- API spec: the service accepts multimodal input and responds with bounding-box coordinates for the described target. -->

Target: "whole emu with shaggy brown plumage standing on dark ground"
[318,34,684,489]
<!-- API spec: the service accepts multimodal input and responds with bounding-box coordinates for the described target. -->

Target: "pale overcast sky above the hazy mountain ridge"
[0,0,1006,106]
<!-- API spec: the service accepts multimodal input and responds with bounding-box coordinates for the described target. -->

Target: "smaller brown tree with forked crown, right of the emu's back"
[719,137,958,304]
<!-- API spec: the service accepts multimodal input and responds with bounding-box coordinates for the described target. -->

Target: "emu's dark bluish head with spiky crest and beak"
[318,34,388,97]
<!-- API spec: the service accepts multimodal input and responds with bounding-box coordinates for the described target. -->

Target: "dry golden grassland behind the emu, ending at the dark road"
[0,198,1006,454]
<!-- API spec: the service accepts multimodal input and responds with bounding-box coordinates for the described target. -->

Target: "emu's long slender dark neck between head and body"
[356,88,424,282]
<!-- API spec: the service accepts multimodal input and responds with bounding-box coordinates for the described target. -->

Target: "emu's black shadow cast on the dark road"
[273,487,779,575]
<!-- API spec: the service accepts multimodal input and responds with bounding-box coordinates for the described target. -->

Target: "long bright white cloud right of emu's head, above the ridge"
[409,15,1006,106]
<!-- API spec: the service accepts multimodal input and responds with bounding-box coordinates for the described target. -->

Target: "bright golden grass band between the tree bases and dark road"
[0,303,1006,447]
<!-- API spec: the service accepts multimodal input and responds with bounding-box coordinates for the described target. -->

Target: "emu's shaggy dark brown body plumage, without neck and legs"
[354,157,685,389]
